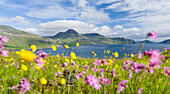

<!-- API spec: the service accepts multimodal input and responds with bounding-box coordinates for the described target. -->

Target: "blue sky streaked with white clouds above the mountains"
[0,0,170,42]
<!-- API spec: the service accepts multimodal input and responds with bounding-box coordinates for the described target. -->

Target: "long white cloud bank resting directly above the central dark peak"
[38,20,96,36]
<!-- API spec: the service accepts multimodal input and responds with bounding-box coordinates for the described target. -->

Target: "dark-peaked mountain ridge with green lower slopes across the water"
[44,29,135,45]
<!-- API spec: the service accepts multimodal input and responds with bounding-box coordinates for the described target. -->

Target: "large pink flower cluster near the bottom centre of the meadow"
[85,74,102,90]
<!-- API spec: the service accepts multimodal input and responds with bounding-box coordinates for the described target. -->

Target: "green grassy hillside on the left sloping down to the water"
[0,25,54,49]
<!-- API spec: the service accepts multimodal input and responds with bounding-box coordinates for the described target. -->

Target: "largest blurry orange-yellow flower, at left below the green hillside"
[19,50,36,62]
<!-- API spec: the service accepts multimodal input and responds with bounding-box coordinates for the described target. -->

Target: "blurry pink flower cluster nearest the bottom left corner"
[11,78,32,94]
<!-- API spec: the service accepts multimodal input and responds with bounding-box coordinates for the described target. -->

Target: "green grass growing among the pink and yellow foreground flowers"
[0,48,170,94]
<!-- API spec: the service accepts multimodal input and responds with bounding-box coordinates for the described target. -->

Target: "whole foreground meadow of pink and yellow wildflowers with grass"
[0,31,170,94]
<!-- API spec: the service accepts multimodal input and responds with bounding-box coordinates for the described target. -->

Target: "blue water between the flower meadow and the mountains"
[37,43,170,58]
